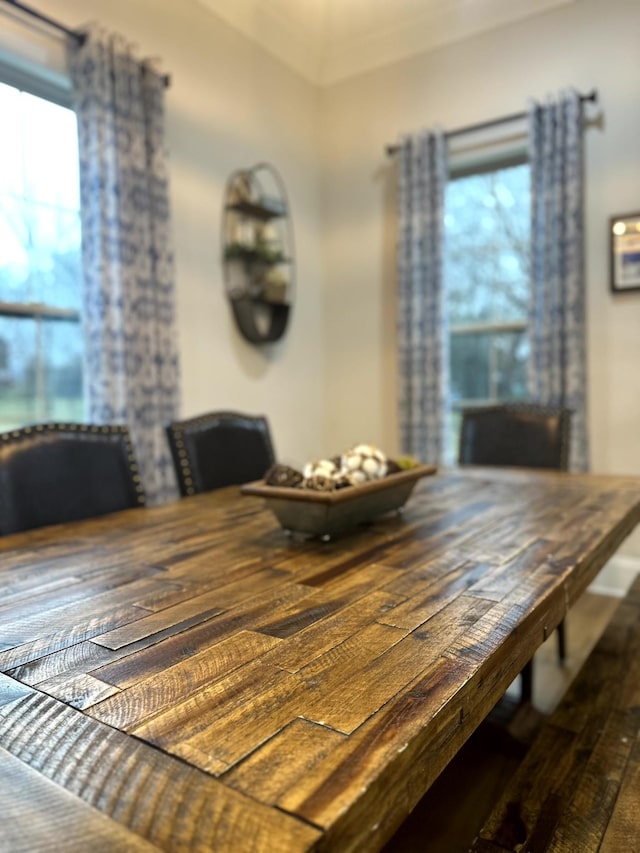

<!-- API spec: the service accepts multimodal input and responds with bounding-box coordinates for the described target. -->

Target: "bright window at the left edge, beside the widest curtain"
[0,78,83,430]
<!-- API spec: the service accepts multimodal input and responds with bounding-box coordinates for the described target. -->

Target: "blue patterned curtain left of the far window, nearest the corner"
[398,132,449,463]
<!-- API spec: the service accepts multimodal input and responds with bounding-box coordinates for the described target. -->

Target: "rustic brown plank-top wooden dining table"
[0,468,640,853]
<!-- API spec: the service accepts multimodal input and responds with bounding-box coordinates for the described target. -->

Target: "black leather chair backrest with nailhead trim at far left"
[0,423,145,535]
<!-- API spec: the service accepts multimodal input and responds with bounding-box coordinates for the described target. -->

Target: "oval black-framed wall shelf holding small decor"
[222,163,294,344]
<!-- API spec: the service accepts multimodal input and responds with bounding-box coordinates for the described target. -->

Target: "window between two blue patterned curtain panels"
[444,158,530,447]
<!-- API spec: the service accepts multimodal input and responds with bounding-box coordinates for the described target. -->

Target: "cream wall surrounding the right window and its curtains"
[321,0,640,555]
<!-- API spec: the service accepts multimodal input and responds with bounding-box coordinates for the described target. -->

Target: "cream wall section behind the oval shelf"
[39,0,324,464]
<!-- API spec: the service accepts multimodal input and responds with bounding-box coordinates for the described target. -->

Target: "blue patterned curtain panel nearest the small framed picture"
[529,91,589,471]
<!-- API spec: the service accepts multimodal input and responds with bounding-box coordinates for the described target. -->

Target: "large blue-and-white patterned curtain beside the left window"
[71,32,179,503]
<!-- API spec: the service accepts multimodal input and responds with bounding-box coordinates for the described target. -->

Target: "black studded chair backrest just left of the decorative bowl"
[166,412,275,496]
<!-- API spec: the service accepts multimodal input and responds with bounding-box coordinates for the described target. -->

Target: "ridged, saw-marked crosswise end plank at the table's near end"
[0,694,319,853]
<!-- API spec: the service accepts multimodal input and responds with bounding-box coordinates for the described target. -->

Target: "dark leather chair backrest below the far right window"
[458,403,571,471]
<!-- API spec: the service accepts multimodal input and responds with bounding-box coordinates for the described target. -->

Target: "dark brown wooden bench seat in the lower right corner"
[473,576,640,853]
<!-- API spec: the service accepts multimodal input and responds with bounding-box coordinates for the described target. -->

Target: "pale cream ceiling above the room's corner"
[196,0,577,85]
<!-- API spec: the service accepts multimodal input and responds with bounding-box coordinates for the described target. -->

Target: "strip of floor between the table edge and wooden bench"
[383,593,619,853]
